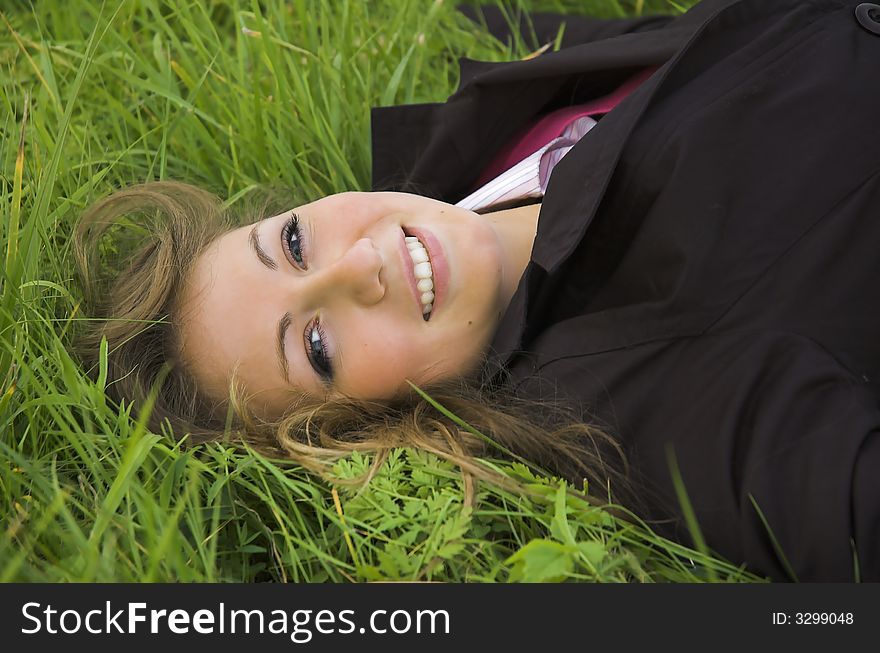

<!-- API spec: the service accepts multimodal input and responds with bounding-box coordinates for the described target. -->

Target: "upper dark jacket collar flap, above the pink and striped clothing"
[371,26,691,204]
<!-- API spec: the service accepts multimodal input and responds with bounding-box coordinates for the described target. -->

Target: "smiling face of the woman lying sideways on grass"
[180,193,509,416]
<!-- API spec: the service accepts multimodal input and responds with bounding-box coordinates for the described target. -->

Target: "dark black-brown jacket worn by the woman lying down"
[373,0,880,581]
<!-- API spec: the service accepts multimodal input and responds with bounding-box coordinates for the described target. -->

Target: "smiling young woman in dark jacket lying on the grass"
[76,0,880,580]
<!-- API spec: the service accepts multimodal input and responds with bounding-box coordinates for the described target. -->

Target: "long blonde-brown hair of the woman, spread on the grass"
[73,181,632,502]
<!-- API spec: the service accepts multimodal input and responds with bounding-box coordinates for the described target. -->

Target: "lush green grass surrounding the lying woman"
[0,0,750,581]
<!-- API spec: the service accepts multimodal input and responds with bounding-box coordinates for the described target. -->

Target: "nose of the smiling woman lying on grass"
[306,238,385,306]
